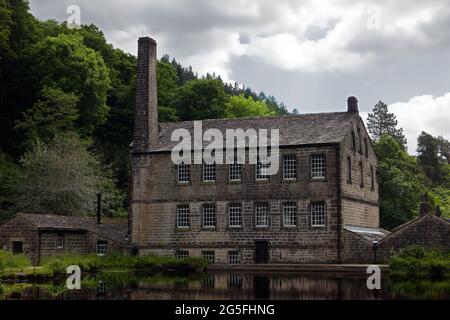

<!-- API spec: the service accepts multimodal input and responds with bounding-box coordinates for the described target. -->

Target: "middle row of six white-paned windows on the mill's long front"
[176,201,326,229]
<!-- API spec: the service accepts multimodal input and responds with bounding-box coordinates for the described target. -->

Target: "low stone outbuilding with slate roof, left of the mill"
[0,213,128,265]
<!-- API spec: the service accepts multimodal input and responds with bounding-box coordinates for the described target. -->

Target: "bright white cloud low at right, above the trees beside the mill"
[389,92,450,154]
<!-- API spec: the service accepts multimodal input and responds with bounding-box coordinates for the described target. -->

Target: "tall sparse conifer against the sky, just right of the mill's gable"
[367,100,407,150]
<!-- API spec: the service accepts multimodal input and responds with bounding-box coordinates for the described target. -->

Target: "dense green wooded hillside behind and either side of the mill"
[0,0,450,228]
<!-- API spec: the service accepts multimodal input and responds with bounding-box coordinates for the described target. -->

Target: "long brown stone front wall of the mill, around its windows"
[132,146,337,263]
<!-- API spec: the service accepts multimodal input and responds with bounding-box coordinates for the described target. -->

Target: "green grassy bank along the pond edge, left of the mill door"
[0,250,208,279]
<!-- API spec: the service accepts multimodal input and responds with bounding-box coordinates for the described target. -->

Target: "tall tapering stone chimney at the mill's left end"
[133,37,159,153]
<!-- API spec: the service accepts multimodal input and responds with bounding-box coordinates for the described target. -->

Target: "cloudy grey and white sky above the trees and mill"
[30,0,450,153]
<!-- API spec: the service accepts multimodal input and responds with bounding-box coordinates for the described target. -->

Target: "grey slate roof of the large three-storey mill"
[152,112,355,152]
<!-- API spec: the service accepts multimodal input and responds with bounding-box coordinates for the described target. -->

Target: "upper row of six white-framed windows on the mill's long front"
[177,154,326,183]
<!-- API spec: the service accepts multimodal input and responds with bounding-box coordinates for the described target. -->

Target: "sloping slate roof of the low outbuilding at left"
[17,213,128,243]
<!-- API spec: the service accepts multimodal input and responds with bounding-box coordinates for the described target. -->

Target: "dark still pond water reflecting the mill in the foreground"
[0,272,450,300]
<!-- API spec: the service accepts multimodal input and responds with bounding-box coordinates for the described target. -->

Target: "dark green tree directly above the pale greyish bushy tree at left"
[16,87,79,146]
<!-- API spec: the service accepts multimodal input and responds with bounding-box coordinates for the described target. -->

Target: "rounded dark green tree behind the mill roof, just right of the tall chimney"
[173,79,228,121]
